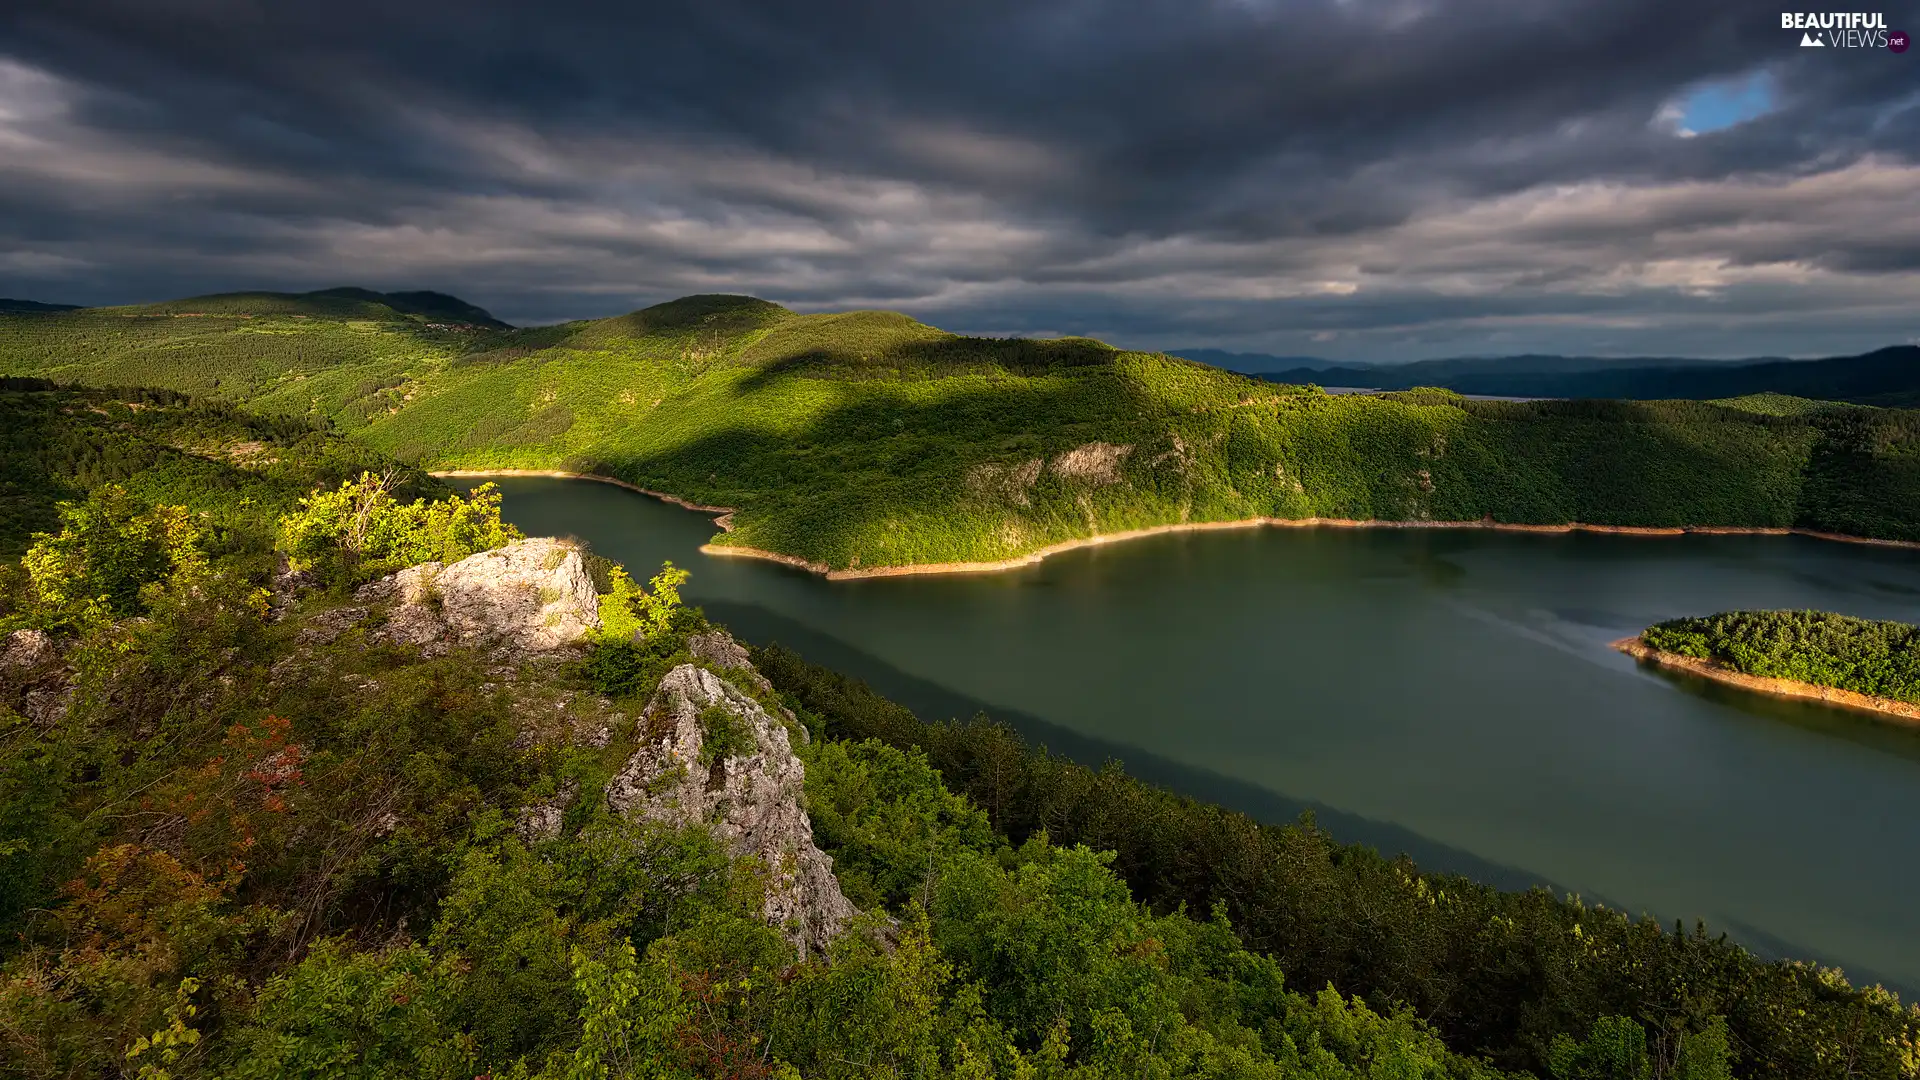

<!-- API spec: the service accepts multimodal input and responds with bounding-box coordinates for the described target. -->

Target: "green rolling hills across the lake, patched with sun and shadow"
[0,296,1920,567]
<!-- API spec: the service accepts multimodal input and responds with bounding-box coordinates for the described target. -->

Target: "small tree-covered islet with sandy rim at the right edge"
[1613,611,1920,723]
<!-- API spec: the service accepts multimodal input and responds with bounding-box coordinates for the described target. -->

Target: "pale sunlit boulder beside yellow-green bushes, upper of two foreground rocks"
[353,536,599,651]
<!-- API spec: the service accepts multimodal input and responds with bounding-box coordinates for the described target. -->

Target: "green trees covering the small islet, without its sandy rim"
[1640,611,1920,705]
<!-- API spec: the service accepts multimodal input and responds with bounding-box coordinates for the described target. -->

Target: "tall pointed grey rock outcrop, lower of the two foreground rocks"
[607,661,858,955]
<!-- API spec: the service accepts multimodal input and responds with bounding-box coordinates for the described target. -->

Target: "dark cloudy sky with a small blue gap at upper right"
[0,0,1920,359]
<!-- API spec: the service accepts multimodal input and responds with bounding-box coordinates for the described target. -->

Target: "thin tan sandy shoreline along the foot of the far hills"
[432,469,1920,580]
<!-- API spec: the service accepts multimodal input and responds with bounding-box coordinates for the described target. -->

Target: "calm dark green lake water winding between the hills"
[459,477,1920,999]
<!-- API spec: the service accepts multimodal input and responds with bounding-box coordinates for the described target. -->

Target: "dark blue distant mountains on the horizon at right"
[1177,346,1920,405]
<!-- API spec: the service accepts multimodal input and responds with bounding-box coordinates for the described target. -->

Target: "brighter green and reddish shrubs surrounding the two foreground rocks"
[0,417,1543,1080]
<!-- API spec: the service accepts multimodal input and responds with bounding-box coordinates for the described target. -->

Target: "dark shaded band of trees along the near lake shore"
[755,646,1920,1080]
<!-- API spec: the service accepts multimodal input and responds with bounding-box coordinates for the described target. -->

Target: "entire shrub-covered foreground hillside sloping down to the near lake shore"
[0,384,1920,1080]
